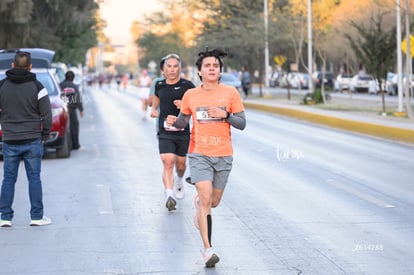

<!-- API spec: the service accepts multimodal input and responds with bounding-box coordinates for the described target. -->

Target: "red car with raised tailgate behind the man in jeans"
[0,48,72,158]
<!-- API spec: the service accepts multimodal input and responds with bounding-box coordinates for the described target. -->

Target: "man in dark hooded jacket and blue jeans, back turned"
[0,52,52,227]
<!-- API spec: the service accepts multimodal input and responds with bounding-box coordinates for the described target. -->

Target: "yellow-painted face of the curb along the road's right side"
[243,102,414,144]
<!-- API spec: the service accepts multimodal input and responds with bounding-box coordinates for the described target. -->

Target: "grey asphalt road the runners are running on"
[0,84,414,274]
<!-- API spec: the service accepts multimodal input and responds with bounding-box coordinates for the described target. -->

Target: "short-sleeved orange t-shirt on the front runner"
[180,83,244,157]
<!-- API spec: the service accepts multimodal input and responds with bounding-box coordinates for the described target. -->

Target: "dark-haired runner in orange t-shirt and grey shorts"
[167,49,246,267]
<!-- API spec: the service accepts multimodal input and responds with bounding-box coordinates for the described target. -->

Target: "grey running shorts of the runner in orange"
[187,154,233,189]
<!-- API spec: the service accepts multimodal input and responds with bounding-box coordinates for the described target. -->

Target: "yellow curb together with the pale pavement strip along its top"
[244,96,414,147]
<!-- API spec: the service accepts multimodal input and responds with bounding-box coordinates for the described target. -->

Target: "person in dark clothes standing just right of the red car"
[60,71,83,150]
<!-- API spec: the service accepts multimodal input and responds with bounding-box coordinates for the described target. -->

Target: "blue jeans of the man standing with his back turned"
[0,138,43,221]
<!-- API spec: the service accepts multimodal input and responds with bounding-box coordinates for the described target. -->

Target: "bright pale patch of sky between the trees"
[100,0,160,45]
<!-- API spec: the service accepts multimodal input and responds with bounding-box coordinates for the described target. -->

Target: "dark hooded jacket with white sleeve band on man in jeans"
[0,68,52,142]
